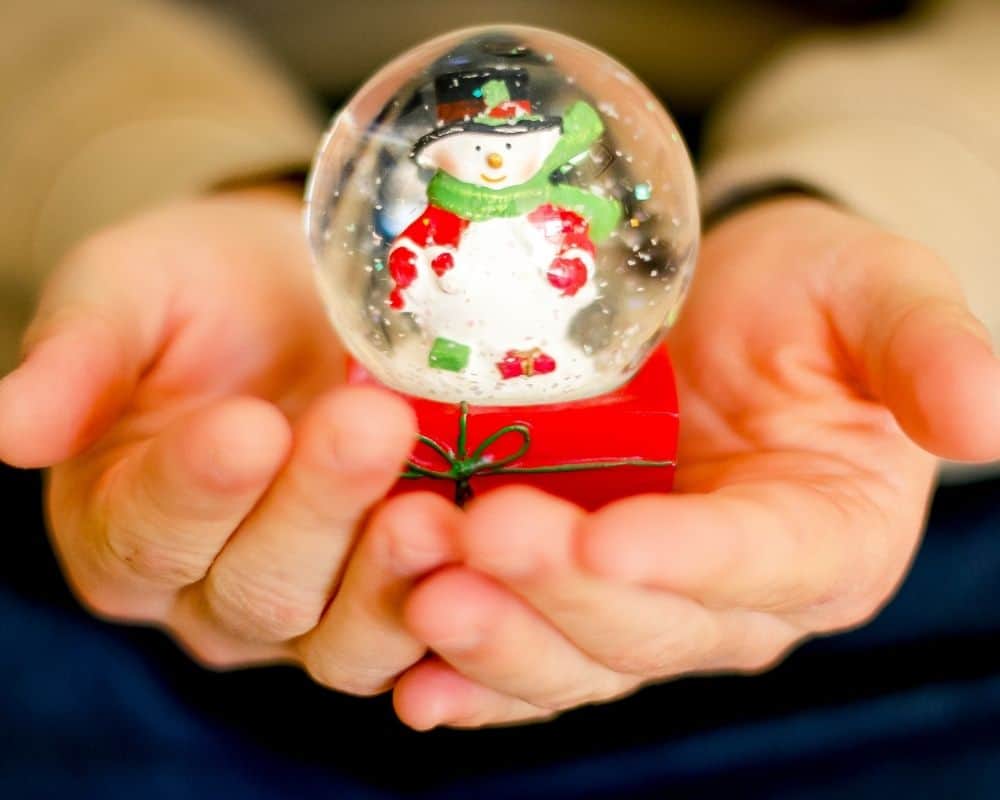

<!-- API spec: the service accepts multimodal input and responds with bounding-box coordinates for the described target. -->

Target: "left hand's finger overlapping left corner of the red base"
[205,387,416,641]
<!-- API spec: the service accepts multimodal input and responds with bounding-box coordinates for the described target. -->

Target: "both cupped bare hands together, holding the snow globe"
[0,191,1000,729]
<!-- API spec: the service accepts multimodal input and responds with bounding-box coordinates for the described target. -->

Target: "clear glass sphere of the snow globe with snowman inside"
[307,26,699,405]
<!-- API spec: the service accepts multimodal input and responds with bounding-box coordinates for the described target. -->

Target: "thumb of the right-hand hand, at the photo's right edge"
[828,233,1000,461]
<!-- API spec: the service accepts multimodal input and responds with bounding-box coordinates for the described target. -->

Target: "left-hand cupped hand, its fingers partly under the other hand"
[0,191,458,693]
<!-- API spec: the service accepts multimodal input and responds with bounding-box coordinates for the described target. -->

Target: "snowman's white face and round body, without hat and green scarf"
[389,119,598,404]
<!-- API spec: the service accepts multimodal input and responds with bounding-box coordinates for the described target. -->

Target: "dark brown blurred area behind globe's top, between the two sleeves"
[186,0,908,136]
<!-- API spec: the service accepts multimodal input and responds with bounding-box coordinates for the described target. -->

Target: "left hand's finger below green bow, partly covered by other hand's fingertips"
[298,493,461,695]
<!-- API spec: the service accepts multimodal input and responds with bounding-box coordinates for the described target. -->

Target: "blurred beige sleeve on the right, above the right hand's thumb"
[702,0,1000,342]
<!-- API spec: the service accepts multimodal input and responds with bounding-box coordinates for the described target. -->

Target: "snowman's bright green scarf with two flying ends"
[427,101,622,242]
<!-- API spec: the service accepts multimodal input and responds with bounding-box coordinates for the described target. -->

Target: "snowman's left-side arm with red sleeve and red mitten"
[389,205,469,310]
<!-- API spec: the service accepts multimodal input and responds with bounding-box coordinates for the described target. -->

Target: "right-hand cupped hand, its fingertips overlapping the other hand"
[395,199,1000,728]
